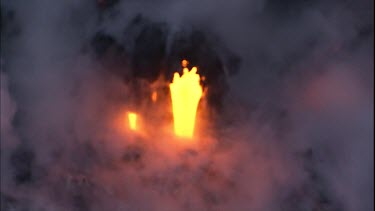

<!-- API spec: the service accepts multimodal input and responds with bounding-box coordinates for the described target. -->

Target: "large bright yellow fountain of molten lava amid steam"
[169,60,203,138]
